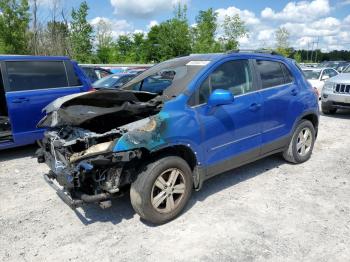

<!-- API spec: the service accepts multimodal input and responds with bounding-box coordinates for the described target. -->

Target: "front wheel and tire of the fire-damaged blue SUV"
[130,156,193,224]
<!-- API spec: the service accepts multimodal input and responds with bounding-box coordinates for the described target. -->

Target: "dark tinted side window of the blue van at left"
[6,61,69,91]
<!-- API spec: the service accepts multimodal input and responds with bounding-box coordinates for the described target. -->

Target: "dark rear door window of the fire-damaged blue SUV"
[256,60,293,89]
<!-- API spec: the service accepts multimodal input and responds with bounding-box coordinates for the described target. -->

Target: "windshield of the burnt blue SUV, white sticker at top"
[122,56,210,98]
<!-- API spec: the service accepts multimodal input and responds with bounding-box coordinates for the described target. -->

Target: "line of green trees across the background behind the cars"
[0,0,350,63]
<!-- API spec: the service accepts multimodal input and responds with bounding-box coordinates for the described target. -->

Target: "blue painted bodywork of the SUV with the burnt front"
[110,53,319,167]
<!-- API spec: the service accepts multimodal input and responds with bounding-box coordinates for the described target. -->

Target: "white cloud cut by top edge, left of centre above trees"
[110,0,189,18]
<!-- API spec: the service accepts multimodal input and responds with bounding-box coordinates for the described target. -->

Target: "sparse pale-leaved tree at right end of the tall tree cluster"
[221,14,248,51]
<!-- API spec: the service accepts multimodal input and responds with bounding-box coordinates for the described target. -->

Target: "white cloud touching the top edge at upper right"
[261,0,331,22]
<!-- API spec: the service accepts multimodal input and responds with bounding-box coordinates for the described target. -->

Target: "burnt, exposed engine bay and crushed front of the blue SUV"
[37,90,163,207]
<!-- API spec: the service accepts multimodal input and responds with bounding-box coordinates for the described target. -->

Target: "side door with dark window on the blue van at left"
[2,60,83,145]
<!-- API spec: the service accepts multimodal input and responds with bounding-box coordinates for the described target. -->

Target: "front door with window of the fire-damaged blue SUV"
[194,60,262,176]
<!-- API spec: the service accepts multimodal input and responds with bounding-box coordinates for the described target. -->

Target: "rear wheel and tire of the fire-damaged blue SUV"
[283,120,316,164]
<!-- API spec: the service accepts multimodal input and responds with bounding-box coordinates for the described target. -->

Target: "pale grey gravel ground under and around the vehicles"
[0,109,350,262]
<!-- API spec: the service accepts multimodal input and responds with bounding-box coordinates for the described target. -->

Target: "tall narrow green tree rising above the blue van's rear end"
[70,1,93,63]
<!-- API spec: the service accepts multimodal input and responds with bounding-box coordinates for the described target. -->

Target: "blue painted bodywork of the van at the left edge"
[0,56,91,149]
